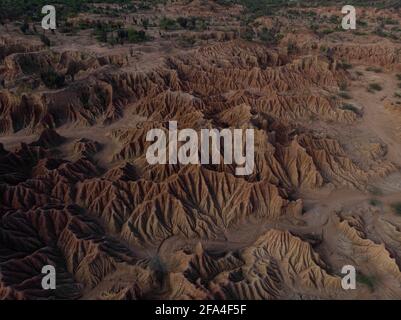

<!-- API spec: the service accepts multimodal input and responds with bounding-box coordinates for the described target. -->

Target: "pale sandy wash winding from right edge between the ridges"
[148,66,401,266]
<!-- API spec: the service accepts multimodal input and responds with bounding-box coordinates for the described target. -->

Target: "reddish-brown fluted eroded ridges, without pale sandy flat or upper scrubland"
[0,13,401,299]
